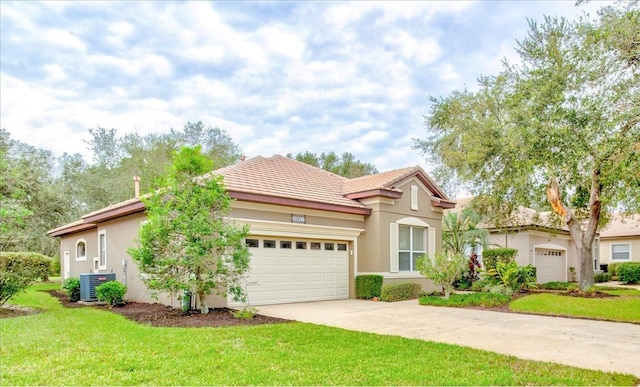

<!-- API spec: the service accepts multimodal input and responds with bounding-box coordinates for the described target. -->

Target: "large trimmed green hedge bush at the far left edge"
[0,252,52,305]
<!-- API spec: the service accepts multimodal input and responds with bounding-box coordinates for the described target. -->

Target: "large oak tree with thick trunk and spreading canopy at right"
[415,2,640,289]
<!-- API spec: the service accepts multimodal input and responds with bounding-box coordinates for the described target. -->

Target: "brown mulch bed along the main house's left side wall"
[39,290,291,327]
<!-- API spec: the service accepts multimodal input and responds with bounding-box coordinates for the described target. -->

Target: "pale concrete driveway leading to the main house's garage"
[258,299,640,377]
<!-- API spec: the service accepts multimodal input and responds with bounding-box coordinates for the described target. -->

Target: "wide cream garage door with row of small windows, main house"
[229,237,349,306]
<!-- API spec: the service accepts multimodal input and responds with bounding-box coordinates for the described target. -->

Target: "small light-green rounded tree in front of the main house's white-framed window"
[418,251,468,299]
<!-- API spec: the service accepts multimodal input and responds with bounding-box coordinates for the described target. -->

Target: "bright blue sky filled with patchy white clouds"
[0,0,602,171]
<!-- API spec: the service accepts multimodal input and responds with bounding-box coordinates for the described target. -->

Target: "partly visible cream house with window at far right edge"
[600,214,640,265]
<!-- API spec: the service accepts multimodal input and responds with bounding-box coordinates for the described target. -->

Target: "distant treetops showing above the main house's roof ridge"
[287,151,378,178]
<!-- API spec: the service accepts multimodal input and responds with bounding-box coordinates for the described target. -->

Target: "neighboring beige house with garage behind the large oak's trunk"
[458,202,600,283]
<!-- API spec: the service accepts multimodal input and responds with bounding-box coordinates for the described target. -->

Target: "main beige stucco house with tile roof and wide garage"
[49,155,455,307]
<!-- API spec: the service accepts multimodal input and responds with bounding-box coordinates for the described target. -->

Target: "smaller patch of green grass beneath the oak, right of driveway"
[509,289,640,323]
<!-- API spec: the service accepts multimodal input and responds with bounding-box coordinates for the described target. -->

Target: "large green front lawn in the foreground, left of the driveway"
[0,284,639,385]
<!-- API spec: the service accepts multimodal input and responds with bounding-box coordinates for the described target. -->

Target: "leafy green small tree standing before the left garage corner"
[129,146,249,313]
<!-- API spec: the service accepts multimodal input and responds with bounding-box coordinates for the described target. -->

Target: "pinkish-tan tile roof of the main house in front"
[49,155,454,235]
